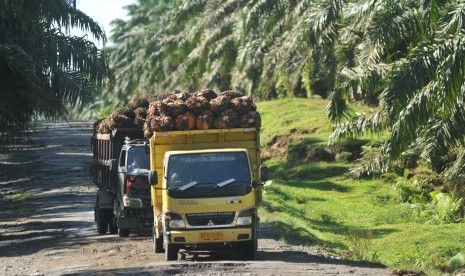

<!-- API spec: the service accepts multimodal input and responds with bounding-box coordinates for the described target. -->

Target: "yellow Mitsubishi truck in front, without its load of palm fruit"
[149,128,268,261]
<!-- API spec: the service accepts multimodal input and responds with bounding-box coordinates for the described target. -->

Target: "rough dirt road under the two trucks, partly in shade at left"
[0,122,389,275]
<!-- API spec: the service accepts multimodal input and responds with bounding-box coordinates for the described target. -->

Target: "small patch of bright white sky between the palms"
[72,0,136,44]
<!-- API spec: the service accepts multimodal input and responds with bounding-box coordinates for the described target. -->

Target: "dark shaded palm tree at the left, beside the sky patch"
[0,0,111,139]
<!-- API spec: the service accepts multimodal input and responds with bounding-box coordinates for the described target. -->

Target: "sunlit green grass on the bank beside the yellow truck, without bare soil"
[258,99,465,274]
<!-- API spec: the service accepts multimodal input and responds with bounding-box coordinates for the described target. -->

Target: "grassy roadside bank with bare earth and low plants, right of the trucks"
[258,99,465,274]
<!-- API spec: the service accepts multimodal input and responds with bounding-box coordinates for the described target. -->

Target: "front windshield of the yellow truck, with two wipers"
[167,152,251,198]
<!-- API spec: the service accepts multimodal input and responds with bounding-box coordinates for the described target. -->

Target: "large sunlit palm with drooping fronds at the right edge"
[329,1,465,190]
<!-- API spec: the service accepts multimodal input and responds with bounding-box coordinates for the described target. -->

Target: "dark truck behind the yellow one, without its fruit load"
[91,128,153,237]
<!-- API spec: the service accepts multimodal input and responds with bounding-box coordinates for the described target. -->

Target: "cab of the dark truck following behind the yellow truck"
[113,139,153,237]
